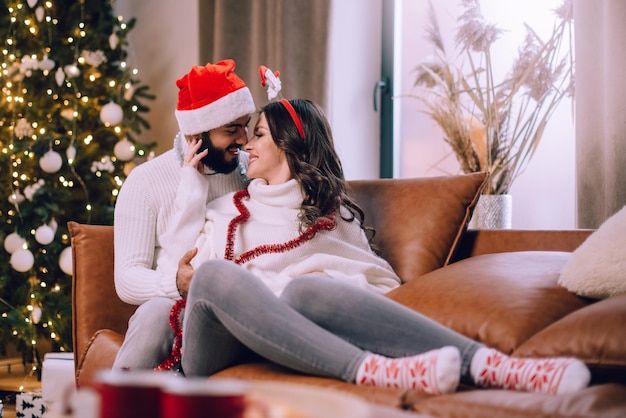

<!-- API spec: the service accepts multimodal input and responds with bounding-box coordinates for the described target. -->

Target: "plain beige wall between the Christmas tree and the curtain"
[115,0,199,154]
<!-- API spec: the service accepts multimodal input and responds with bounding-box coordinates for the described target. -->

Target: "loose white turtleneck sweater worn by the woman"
[157,167,400,295]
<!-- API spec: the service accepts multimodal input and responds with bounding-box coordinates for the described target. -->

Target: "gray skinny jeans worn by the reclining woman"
[182,260,482,382]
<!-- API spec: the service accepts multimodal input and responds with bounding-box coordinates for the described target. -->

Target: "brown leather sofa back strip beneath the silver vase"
[453,229,594,261]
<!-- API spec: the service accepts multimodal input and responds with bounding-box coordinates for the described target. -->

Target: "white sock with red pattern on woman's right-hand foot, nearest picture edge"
[470,347,591,394]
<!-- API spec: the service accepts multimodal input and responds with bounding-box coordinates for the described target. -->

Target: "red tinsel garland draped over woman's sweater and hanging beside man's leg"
[156,189,336,370]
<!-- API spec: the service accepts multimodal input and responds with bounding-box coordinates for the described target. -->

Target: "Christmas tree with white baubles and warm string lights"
[0,0,153,362]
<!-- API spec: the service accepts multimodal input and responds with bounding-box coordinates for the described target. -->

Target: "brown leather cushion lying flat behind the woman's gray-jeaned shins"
[387,251,589,354]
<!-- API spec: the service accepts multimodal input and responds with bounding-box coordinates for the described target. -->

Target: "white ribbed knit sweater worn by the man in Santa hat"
[114,133,248,305]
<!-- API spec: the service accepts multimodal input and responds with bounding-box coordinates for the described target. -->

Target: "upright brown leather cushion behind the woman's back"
[349,173,487,282]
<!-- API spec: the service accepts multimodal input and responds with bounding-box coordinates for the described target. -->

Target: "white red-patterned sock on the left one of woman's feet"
[356,346,461,395]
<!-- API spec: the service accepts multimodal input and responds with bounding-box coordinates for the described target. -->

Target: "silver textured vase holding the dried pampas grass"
[469,194,513,229]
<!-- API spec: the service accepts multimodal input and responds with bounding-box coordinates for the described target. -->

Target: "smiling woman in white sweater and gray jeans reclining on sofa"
[162,100,590,394]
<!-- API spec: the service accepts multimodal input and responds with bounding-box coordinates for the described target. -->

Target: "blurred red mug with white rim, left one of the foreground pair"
[95,370,172,418]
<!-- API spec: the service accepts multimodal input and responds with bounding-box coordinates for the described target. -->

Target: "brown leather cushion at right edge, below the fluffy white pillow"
[514,294,626,383]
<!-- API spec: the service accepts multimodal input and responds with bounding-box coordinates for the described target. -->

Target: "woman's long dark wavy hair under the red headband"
[261,100,364,233]
